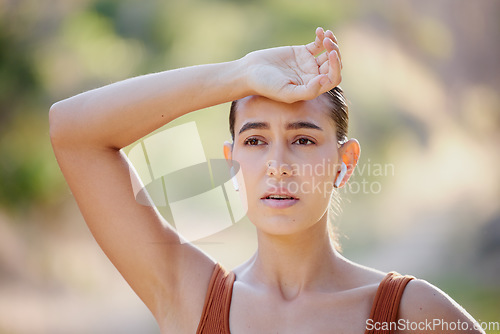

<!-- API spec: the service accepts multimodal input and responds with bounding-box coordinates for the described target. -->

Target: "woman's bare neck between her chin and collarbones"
[243,215,342,300]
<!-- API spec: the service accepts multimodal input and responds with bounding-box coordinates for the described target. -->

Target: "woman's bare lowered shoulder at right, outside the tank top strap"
[398,279,484,334]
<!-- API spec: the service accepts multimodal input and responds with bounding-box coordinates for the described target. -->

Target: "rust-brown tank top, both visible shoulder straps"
[196,263,414,334]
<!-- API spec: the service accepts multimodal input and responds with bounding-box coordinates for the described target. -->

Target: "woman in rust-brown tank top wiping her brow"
[50,28,482,333]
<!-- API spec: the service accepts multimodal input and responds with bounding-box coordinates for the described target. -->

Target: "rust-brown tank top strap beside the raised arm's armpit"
[196,263,236,334]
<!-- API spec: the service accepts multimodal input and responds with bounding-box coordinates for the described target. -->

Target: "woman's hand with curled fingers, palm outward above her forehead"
[242,28,342,103]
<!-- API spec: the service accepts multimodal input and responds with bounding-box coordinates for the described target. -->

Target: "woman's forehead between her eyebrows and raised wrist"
[234,96,335,133]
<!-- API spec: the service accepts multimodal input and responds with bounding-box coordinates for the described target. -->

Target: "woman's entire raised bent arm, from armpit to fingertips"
[50,29,341,332]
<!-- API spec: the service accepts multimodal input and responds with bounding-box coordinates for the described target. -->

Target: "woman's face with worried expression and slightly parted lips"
[232,96,339,235]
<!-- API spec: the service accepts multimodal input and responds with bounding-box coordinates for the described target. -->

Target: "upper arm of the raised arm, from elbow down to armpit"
[53,143,214,328]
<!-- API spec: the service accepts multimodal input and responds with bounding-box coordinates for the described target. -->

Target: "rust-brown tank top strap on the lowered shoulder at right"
[365,271,415,334]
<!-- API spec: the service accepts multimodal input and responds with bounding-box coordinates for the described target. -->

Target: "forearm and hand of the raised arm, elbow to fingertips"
[50,28,340,149]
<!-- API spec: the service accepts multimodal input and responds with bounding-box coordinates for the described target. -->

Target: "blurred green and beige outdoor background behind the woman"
[0,0,500,334]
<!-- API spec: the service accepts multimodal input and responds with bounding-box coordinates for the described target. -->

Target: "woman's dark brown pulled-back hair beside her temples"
[229,86,349,144]
